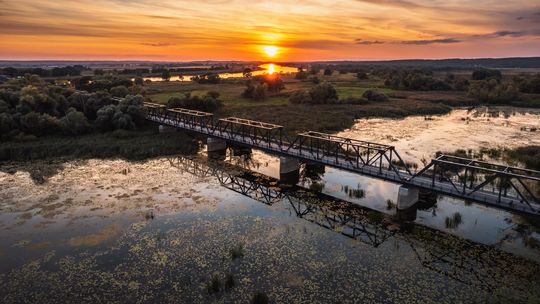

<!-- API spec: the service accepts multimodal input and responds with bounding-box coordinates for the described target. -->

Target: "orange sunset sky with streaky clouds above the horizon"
[0,0,540,61]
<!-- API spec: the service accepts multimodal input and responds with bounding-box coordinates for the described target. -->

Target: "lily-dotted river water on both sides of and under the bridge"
[0,110,540,303]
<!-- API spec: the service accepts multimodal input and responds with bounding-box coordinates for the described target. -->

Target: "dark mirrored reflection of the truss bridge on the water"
[169,157,538,292]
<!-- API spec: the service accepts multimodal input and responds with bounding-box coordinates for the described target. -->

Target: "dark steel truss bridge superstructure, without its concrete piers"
[144,102,540,215]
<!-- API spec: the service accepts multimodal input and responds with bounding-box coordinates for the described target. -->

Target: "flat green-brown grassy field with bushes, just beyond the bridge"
[147,73,462,134]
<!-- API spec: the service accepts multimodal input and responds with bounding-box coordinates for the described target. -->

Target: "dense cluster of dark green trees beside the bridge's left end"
[0,75,146,140]
